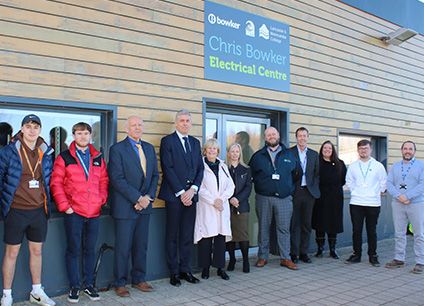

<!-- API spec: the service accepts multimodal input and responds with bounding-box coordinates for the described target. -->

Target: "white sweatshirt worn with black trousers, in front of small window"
[346,157,387,207]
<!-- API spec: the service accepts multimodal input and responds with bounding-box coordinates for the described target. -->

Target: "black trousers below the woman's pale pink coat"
[197,235,225,269]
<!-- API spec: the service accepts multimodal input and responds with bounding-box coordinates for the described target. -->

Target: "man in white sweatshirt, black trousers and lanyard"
[346,139,387,267]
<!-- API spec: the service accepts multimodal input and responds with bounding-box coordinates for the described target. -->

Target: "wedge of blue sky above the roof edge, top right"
[339,0,424,34]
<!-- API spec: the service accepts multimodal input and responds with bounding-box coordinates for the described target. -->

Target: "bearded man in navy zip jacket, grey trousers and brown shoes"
[249,127,297,270]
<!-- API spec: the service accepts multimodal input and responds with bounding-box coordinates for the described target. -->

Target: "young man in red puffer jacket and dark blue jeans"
[50,122,109,303]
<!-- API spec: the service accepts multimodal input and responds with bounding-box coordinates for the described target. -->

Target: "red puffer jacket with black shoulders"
[50,142,109,218]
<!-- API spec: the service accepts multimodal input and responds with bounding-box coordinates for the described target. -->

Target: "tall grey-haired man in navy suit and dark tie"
[158,110,204,287]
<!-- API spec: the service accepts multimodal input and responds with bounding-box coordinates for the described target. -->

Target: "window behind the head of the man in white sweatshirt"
[339,132,387,168]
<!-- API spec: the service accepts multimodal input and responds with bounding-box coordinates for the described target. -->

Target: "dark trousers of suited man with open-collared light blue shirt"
[290,188,315,256]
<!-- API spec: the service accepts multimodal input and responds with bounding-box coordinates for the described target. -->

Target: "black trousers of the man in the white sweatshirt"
[349,205,380,256]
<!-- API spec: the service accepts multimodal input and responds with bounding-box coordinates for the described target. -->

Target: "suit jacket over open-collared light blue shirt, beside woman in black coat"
[290,146,321,199]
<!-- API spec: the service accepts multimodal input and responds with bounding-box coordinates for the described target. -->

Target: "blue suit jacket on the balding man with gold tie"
[108,137,159,219]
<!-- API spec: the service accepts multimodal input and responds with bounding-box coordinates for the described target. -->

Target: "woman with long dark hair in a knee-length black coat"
[312,140,346,259]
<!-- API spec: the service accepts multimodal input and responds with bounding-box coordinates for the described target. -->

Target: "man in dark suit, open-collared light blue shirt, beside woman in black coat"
[290,127,320,263]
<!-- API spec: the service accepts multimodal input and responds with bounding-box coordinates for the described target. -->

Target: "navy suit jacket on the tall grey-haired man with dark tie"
[158,132,204,202]
